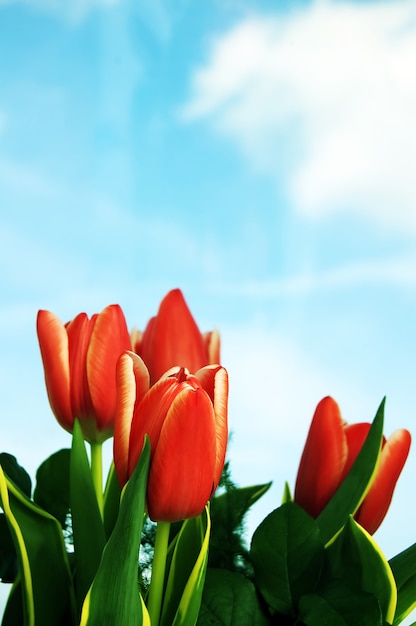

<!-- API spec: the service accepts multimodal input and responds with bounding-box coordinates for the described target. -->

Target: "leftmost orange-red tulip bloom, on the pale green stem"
[37,304,131,442]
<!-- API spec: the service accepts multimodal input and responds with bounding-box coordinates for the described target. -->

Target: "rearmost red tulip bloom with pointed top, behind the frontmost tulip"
[132,289,220,384]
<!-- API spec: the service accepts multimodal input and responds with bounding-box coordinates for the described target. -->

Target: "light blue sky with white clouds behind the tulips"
[0,0,416,608]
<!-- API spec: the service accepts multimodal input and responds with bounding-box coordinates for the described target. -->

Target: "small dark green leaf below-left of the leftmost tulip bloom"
[33,448,71,529]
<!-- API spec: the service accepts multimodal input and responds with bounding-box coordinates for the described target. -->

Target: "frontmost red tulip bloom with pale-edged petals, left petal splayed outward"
[114,352,228,522]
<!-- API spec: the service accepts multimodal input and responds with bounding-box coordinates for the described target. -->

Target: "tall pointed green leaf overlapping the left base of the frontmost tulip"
[80,437,150,626]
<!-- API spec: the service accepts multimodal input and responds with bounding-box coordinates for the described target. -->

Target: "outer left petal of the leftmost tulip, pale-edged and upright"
[37,311,74,432]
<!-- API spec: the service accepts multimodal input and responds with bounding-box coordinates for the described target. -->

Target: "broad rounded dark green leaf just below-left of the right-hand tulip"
[251,502,325,616]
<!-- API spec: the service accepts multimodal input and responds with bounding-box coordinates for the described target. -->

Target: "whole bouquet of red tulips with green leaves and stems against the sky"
[0,289,416,626]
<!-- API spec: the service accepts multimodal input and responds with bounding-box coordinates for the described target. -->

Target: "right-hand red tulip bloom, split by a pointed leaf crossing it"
[294,397,411,534]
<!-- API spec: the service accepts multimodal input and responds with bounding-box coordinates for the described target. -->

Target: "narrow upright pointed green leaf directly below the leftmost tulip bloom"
[70,420,105,608]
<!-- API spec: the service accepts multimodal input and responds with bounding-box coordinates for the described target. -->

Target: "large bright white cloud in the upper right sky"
[182,0,416,231]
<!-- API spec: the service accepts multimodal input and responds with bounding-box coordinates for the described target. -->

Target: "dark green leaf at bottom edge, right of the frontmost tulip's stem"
[197,568,270,626]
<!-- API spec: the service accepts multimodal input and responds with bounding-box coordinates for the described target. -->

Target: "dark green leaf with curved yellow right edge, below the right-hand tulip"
[320,516,397,624]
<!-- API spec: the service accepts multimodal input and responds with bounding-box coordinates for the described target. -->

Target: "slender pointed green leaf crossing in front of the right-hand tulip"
[316,399,385,543]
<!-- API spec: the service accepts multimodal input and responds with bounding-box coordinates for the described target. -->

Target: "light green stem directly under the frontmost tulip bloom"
[147,522,170,626]
